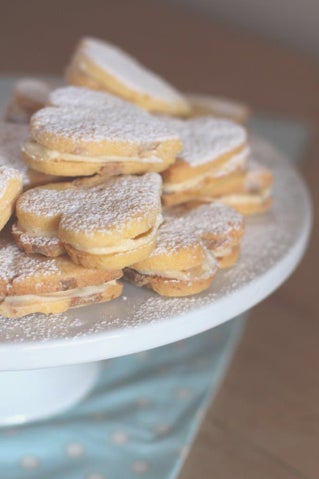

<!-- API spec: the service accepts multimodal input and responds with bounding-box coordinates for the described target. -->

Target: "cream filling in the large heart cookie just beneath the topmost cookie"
[23,141,163,164]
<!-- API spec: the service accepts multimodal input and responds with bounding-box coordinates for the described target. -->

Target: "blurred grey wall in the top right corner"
[168,0,319,56]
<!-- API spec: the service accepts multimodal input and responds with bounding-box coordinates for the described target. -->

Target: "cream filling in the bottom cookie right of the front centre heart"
[136,251,217,281]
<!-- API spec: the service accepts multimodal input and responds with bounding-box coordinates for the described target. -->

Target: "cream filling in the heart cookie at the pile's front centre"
[72,215,163,255]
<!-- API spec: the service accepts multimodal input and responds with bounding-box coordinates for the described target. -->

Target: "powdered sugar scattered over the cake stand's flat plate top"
[0,139,308,359]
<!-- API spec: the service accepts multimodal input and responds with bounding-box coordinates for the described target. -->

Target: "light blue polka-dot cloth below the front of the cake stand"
[0,316,244,479]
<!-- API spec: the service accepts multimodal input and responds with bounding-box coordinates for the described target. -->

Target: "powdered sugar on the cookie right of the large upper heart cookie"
[163,117,248,167]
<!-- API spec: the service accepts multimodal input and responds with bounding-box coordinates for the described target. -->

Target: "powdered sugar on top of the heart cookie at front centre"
[18,173,161,235]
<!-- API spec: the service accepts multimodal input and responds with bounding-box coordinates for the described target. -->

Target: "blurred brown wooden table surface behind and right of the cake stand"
[0,0,319,479]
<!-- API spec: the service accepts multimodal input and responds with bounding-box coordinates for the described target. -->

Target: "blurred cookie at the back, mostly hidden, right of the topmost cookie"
[186,93,251,123]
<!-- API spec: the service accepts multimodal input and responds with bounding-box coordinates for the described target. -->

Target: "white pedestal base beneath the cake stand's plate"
[0,363,100,427]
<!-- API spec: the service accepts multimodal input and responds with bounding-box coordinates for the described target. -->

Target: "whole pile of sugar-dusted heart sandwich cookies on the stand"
[0,38,272,317]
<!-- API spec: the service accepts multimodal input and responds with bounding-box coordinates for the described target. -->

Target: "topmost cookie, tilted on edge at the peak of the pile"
[66,37,190,115]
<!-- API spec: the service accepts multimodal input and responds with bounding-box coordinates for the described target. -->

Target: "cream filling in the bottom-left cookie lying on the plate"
[0,279,116,306]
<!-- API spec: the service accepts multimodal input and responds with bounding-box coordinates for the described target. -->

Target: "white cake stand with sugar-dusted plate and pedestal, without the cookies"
[0,84,311,426]
